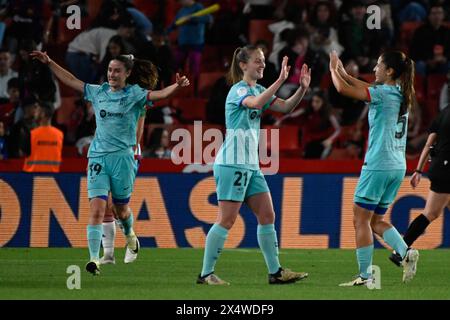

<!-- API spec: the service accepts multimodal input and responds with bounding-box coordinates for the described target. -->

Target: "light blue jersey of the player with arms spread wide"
[84,83,148,158]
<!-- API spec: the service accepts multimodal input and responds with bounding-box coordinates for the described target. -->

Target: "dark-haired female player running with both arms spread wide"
[31,51,189,275]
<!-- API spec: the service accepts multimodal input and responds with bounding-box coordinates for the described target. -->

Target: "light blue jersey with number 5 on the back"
[363,85,408,170]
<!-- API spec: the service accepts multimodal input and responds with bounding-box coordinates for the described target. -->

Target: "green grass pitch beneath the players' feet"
[0,248,450,300]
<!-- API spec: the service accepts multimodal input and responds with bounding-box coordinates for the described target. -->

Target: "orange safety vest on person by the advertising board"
[23,126,64,172]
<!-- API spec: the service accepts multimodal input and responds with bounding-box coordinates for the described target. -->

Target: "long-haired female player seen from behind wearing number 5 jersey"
[330,51,419,286]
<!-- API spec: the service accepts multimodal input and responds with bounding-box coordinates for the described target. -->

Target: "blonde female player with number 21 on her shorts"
[197,45,311,285]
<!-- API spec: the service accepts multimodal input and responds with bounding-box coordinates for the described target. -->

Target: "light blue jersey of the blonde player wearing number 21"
[214,81,276,170]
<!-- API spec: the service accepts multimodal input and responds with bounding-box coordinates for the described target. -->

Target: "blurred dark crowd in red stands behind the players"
[0,0,450,159]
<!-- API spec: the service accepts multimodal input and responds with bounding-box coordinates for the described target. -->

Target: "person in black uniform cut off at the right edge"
[390,106,450,266]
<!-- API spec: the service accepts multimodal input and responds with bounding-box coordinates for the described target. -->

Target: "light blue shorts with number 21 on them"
[214,165,269,202]
